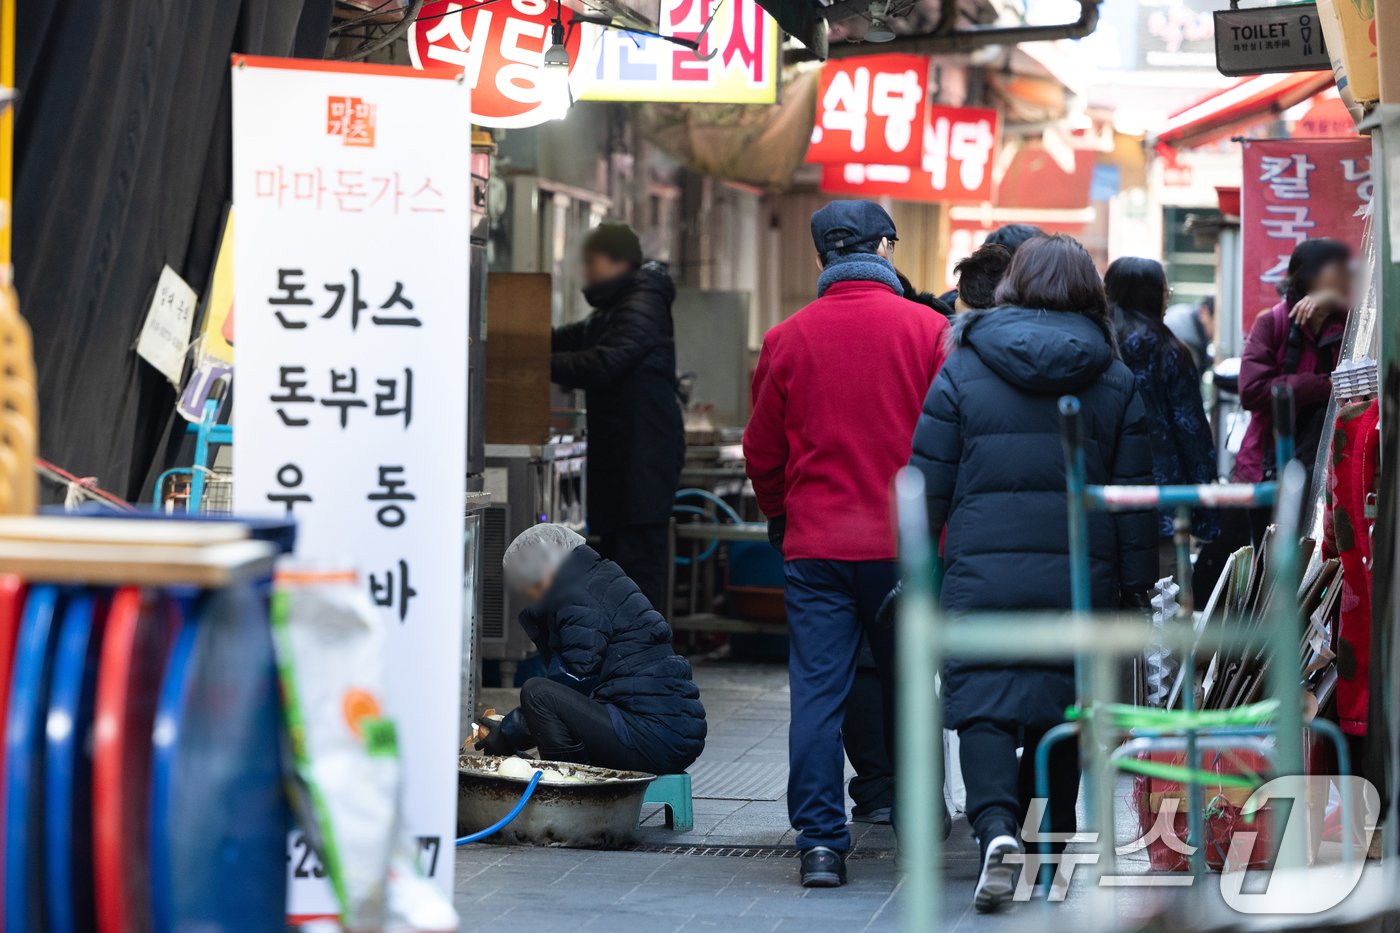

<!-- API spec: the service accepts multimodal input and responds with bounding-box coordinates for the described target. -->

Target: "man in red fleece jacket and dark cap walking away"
[743,200,948,887]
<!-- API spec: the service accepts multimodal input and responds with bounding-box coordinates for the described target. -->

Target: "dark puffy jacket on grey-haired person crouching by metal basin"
[519,545,706,775]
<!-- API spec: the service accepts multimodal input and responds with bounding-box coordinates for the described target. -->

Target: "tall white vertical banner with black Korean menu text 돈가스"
[234,57,472,916]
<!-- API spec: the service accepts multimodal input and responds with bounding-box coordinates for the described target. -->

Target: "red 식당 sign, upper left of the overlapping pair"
[806,55,928,167]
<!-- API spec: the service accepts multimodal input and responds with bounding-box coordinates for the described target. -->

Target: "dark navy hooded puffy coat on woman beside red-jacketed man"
[910,308,1158,728]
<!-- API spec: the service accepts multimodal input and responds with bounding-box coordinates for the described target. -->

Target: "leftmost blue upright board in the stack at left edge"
[4,586,60,933]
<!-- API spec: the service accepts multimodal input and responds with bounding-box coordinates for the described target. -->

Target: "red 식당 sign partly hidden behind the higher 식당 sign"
[822,105,998,203]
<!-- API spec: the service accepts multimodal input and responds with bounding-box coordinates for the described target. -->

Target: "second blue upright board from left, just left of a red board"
[43,590,105,933]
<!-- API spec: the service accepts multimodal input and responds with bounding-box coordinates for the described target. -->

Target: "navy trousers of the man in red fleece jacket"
[784,560,899,852]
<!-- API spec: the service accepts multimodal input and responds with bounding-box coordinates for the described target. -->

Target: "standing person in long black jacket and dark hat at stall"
[550,221,686,611]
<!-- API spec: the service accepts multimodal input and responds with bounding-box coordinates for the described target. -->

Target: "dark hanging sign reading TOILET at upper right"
[1215,3,1331,77]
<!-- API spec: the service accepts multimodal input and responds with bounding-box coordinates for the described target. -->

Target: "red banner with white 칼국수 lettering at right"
[1240,137,1375,326]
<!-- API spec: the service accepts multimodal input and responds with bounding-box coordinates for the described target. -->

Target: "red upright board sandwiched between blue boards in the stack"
[92,587,172,933]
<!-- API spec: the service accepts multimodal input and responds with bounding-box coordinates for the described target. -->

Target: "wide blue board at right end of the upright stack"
[151,586,291,933]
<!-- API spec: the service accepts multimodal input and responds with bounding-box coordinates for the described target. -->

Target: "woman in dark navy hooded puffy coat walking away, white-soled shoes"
[910,235,1156,911]
